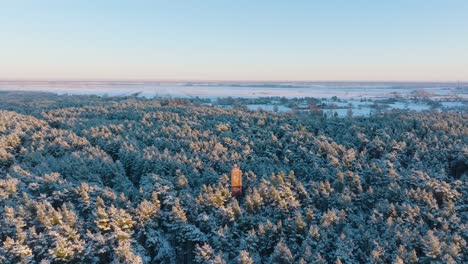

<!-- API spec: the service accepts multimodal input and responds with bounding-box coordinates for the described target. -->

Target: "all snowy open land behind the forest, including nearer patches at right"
[0,81,468,117]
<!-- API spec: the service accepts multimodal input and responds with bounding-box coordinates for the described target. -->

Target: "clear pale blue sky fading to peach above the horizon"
[0,0,468,81]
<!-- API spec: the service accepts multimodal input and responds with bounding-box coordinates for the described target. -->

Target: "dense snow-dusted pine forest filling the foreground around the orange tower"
[0,92,468,264]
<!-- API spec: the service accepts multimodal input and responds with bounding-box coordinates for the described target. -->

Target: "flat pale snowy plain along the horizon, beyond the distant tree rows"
[0,82,468,99]
